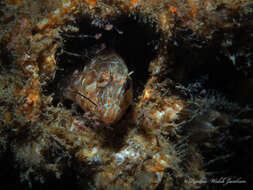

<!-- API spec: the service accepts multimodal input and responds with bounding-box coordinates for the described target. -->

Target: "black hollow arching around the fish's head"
[44,15,160,111]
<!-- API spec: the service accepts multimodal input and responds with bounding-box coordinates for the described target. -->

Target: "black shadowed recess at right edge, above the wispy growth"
[168,28,253,105]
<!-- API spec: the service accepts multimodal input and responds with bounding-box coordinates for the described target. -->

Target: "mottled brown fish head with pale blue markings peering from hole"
[63,50,133,124]
